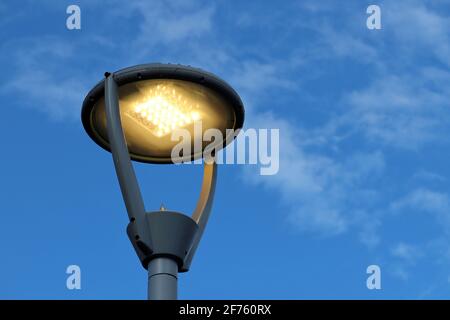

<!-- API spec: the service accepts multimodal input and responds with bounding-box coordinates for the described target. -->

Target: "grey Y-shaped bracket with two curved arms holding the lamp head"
[105,73,217,272]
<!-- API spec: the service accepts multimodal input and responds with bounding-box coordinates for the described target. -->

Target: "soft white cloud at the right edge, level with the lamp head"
[346,72,450,149]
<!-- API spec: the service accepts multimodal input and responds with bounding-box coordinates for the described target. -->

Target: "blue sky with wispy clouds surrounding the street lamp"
[0,0,450,299]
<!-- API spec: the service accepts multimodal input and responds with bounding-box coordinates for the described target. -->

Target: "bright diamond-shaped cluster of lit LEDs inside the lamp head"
[126,85,201,137]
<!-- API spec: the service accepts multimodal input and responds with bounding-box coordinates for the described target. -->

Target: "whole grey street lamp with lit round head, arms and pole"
[81,64,244,300]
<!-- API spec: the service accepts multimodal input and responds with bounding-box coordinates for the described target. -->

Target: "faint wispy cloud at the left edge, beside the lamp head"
[0,37,92,120]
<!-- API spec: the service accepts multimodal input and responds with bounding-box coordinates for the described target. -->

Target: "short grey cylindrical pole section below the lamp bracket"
[148,257,178,300]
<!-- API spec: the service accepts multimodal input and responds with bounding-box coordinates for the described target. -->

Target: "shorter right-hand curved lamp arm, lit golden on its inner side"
[184,159,217,270]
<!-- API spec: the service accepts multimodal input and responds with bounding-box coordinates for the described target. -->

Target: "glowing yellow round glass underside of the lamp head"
[85,79,237,163]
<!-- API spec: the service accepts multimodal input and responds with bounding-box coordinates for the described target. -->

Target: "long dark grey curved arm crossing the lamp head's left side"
[105,73,152,248]
